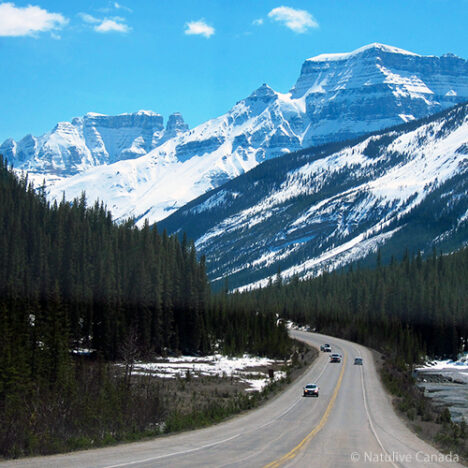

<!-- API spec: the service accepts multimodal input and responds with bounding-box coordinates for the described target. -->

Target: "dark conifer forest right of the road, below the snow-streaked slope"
[237,248,468,363]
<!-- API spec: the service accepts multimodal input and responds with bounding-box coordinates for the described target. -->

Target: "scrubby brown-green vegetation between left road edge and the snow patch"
[2,343,316,458]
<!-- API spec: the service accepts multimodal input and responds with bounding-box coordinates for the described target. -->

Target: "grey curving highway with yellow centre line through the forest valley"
[0,331,463,468]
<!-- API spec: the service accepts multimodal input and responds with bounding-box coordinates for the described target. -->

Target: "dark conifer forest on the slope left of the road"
[0,155,288,395]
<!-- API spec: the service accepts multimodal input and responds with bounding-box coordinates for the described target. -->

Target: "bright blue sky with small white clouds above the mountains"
[0,0,468,142]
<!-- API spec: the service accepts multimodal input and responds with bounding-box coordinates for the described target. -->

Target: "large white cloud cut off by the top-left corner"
[0,3,68,36]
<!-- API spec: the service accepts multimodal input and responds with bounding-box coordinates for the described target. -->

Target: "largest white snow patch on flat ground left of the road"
[122,354,286,391]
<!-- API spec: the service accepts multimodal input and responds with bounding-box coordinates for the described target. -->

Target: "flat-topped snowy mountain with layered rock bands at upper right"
[291,44,468,146]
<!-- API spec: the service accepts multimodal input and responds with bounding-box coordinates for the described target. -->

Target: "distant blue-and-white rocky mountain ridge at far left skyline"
[0,111,188,177]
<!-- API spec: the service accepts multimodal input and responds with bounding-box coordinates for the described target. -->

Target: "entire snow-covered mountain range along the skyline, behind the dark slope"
[0,44,468,223]
